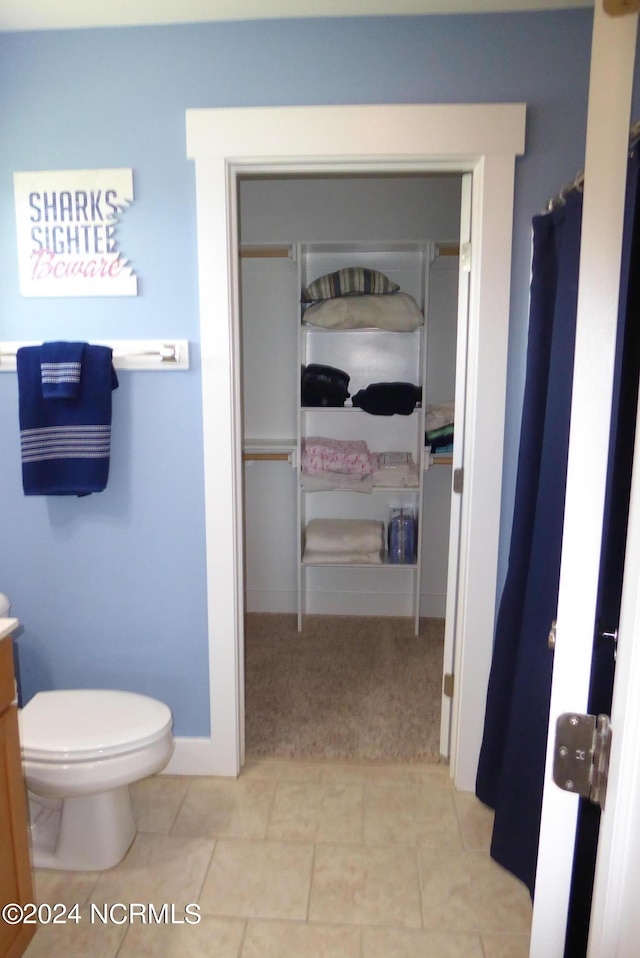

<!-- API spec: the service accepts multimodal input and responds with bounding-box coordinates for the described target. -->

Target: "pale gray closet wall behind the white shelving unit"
[240,175,460,618]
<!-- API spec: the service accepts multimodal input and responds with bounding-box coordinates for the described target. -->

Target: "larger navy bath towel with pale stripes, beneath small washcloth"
[16,343,118,496]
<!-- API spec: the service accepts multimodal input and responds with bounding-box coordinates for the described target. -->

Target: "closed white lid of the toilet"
[19,689,172,761]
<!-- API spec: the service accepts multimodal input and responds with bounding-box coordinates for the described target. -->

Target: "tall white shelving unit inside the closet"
[296,242,434,634]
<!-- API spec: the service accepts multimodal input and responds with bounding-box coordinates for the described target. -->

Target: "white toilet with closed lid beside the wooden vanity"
[19,689,173,871]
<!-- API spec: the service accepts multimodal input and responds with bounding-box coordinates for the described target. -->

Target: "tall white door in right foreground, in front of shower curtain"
[530,4,639,958]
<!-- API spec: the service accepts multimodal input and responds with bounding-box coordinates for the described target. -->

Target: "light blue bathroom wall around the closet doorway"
[0,10,620,735]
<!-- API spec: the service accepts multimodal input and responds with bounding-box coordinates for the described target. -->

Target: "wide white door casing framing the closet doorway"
[187,103,525,790]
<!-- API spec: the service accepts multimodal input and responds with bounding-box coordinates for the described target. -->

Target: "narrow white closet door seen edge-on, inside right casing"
[440,173,473,758]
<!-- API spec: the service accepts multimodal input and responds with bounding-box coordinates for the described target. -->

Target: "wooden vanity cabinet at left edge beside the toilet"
[0,636,37,958]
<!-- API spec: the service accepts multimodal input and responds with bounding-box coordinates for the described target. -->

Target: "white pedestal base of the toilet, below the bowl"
[29,785,136,871]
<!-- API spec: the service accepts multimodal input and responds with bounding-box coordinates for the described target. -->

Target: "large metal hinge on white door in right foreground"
[553,712,612,808]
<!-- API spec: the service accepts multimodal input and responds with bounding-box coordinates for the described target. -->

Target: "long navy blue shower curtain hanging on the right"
[476,142,640,895]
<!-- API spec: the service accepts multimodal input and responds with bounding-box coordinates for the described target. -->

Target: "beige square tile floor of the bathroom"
[26,760,531,958]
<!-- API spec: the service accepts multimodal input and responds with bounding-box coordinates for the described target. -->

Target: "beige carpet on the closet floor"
[245,613,444,762]
